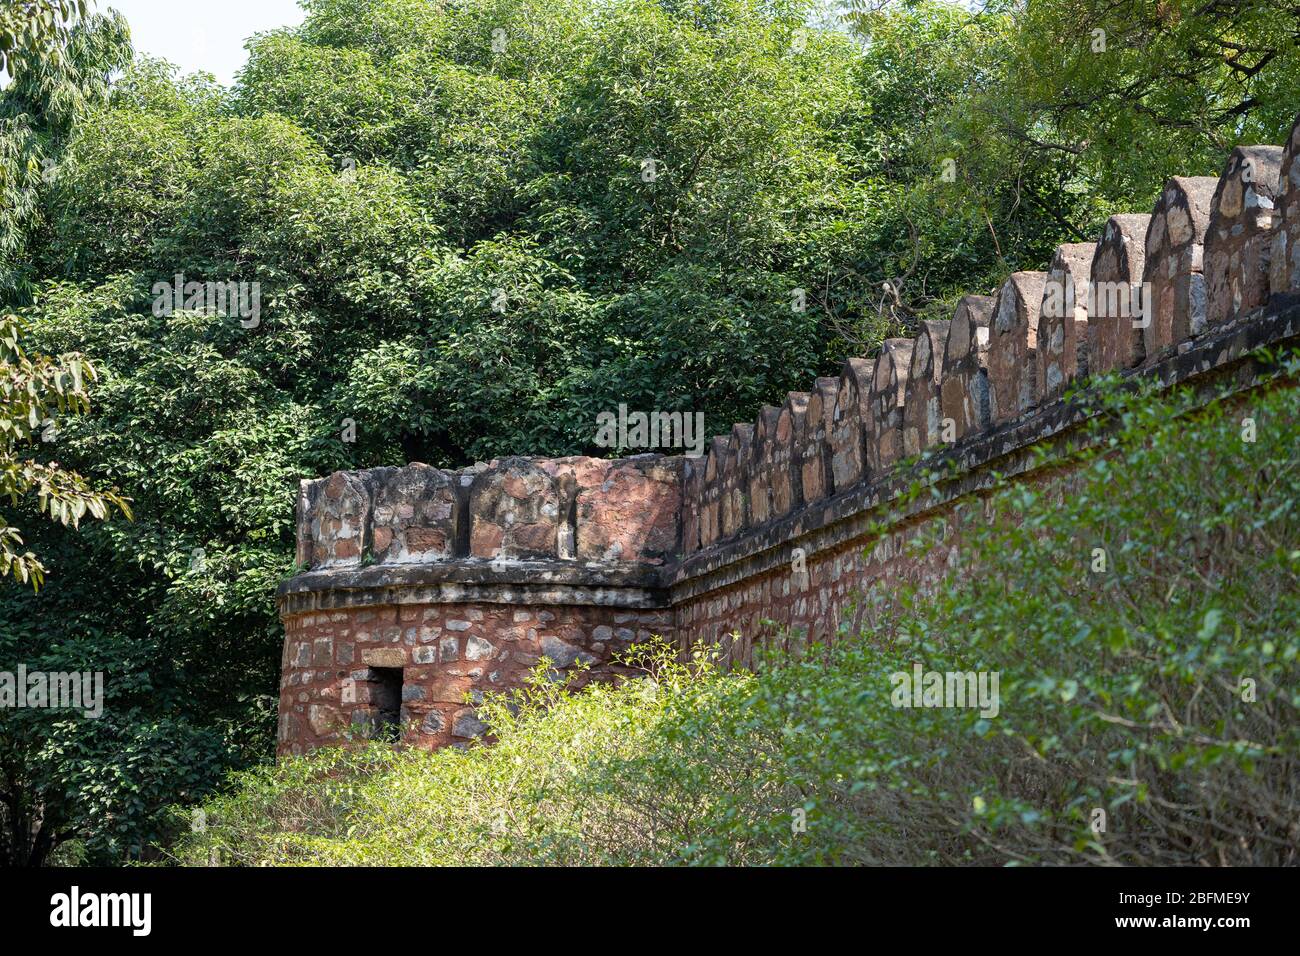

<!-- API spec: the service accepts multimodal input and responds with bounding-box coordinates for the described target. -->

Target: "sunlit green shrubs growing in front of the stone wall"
[178,369,1300,865]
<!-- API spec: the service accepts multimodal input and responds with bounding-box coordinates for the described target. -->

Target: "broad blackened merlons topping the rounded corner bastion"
[298,455,684,570]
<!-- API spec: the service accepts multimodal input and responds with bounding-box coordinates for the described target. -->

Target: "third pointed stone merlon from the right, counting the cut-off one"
[1141,176,1218,362]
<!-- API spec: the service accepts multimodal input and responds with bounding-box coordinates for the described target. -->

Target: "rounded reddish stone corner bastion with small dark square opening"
[280,455,685,753]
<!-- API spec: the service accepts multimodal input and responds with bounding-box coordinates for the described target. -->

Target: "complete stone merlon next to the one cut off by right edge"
[1205,146,1282,326]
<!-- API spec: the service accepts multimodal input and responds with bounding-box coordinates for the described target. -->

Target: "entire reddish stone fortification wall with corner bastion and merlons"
[280,110,1300,753]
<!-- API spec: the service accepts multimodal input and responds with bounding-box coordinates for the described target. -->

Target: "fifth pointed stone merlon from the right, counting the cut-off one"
[1036,242,1097,402]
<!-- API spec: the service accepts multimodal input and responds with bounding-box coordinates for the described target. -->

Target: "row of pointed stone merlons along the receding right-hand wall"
[670,115,1300,561]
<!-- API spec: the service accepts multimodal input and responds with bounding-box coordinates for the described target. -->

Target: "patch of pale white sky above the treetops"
[104,0,306,86]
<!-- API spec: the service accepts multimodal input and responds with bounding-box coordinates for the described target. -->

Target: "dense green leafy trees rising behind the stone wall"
[0,0,1297,860]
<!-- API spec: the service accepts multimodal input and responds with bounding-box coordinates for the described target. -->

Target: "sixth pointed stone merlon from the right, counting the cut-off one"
[988,272,1048,424]
